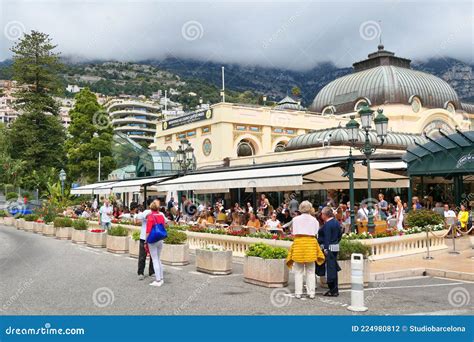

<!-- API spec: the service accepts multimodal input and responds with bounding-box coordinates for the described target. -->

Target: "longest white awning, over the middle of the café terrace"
[159,162,337,192]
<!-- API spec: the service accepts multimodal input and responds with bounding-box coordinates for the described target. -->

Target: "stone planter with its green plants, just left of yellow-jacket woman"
[244,243,289,287]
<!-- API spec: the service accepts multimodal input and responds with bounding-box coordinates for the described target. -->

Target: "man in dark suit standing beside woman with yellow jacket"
[318,207,342,297]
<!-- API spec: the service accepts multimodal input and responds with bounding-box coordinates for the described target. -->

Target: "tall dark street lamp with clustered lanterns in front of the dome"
[346,103,388,232]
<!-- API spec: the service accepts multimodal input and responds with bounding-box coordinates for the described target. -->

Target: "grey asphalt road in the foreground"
[0,226,474,315]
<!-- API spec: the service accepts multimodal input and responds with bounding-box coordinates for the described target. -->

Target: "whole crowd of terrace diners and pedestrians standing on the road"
[64,193,473,298]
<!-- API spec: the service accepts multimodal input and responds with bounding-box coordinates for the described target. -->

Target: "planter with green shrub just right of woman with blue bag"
[161,229,189,266]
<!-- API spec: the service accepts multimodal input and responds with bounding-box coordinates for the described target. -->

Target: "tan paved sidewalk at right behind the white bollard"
[370,236,474,281]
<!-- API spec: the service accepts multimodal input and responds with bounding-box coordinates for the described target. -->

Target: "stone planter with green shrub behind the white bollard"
[319,239,370,288]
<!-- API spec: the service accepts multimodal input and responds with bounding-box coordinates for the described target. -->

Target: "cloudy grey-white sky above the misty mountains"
[0,0,474,70]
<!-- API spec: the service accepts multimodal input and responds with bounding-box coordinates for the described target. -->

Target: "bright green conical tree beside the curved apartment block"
[66,88,115,183]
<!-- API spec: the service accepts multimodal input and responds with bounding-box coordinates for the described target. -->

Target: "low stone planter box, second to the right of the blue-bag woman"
[196,249,232,275]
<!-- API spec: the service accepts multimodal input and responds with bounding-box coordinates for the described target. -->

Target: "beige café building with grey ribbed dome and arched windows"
[154,46,474,168]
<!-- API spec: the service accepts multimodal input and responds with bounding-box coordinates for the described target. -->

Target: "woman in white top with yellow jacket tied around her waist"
[286,201,325,299]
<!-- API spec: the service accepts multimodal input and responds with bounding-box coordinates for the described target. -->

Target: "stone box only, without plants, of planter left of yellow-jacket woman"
[244,256,289,287]
